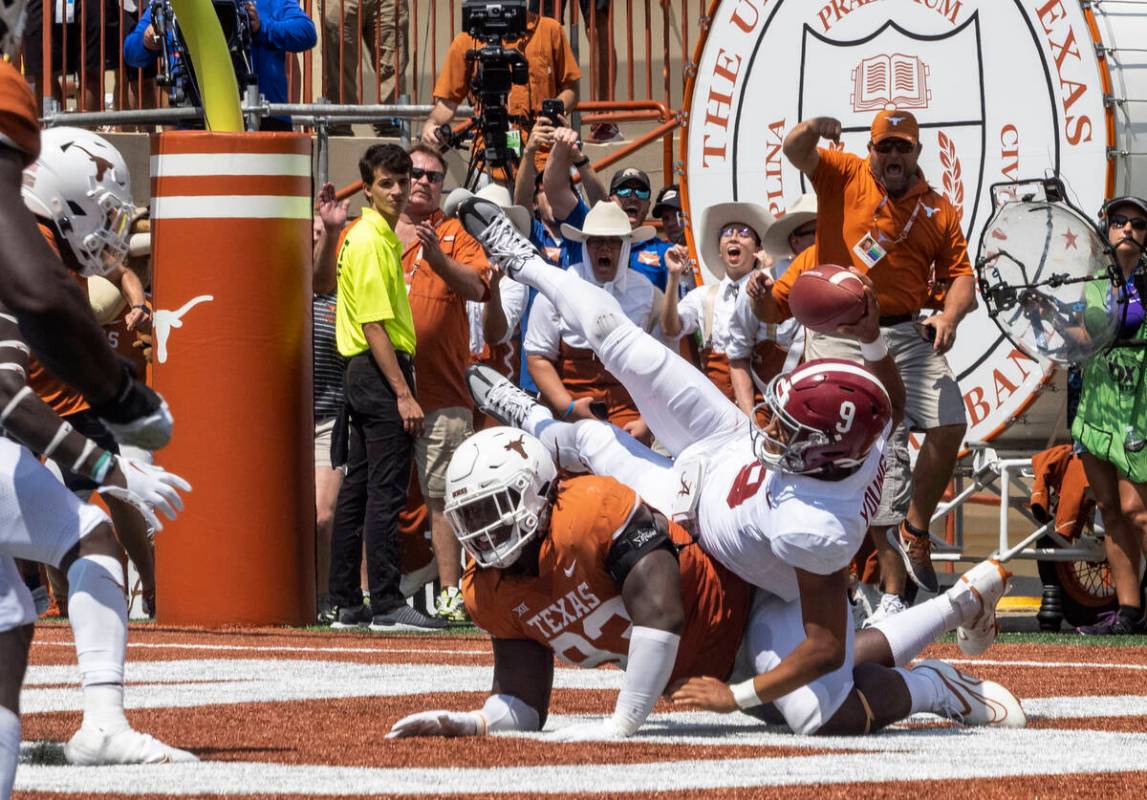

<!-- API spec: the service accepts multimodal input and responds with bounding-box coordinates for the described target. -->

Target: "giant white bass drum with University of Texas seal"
[680,0,1147,450]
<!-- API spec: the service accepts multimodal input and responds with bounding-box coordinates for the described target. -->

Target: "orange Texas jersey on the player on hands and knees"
[462,475,751,681]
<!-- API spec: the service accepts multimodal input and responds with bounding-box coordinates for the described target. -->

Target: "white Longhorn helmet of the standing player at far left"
[22,125,135,275]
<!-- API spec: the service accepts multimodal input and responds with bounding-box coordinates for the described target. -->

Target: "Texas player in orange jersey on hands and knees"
[389,427,1024,741]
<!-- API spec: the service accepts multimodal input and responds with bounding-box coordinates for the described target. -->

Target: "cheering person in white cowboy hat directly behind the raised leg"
[523,201,664,442]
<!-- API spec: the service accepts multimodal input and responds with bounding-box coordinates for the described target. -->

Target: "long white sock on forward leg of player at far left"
[68,556,127,730]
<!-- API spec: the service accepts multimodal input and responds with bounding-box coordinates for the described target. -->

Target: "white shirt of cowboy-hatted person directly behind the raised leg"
[522,264,661,362]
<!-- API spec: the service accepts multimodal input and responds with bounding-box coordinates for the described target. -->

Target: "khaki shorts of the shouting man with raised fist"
[804,323,967,432]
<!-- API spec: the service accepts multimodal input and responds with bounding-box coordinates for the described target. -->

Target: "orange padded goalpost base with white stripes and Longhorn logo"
[151,132,314,626]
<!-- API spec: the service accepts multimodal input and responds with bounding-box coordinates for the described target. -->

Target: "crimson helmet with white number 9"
[751,358,892,475]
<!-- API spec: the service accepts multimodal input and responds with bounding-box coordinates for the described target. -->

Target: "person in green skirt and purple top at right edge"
[1071,197,1147,636]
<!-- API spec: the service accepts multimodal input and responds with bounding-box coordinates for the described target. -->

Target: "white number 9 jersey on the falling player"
[682,427,890,600]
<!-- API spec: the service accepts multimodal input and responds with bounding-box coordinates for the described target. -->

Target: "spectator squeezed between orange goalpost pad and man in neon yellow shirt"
[311,182,350,623]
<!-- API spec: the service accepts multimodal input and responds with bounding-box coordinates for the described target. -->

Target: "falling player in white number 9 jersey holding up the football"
[447,194,1022,732]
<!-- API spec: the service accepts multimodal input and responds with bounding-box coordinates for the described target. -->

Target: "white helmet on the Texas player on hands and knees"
[445,427,557,568]
